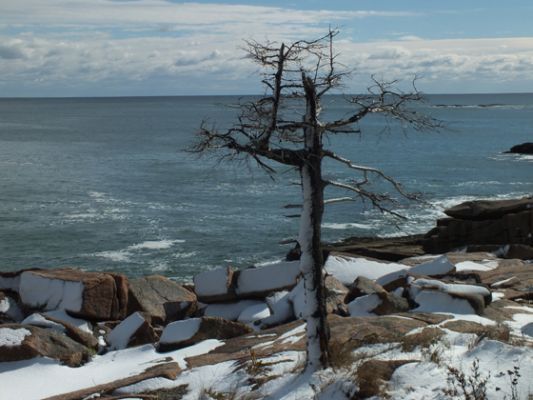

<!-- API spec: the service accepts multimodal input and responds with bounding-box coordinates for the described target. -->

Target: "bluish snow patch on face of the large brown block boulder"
[19,271,83,312]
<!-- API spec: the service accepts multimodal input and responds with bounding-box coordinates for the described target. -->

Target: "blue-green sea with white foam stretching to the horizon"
[0,94,533,278]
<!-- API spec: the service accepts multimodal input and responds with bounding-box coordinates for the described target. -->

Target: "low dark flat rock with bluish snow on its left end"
[158,317,253,352]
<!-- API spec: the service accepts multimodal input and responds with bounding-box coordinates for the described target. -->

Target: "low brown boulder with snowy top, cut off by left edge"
[0,324,90,367]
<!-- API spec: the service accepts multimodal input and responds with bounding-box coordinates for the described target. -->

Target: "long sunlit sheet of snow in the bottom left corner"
[0,339,224,400]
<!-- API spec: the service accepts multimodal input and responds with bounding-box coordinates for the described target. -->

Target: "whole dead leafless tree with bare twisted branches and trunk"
[192,30,437,370]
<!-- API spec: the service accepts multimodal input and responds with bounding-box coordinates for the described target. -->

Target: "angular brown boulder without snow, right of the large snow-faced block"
[128,275,197,323]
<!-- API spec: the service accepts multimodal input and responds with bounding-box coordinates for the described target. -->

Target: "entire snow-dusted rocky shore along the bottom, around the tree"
[0,198,533,400]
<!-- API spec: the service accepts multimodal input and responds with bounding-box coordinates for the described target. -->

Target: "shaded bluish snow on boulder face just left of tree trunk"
[236,261,300,296]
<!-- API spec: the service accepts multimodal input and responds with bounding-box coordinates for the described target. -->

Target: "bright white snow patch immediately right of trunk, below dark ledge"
[324,255,405,286]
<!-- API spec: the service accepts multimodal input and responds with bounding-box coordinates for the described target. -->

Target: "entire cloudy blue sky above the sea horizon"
[0,0,533,97]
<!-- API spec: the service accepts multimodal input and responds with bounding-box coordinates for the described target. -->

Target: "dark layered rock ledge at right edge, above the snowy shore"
[423,197,533,256]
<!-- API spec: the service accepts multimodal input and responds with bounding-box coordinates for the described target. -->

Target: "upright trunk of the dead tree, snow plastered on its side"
[298,75,329,370]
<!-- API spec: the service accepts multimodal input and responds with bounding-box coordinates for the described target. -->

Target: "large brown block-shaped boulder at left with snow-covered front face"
[19,269,128,320]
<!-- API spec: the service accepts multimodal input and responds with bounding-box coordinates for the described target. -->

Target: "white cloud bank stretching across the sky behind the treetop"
[0,0,533,95]
